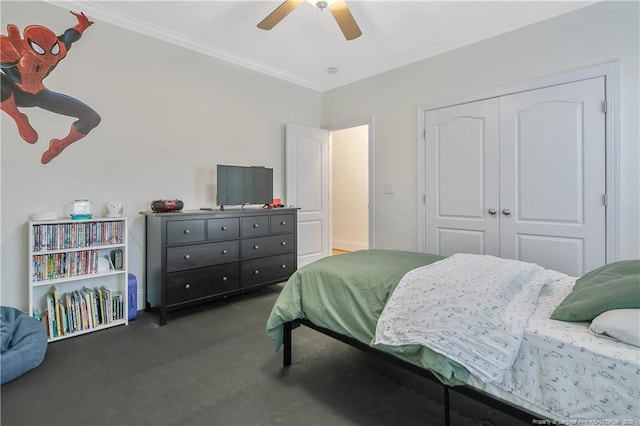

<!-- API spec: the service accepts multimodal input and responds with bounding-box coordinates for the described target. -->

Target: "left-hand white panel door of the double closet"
[425,99,500,256]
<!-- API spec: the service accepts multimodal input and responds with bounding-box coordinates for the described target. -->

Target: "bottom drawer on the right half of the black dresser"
[240,253,296,288]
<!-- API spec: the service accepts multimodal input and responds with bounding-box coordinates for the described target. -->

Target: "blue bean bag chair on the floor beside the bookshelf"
[0,306,47,385]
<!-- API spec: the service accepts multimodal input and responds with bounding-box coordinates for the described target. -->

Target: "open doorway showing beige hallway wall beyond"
[330,124,372,254]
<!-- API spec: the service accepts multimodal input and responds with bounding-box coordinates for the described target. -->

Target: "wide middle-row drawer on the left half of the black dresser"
[167,240,239,272]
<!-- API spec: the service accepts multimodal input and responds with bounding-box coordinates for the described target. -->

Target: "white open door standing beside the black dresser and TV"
[285,124,331,267]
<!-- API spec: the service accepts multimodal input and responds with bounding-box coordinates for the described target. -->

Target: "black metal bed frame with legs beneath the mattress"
[282,319,543,426]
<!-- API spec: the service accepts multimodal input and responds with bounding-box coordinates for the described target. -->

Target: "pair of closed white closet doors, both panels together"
[425,77,606,276]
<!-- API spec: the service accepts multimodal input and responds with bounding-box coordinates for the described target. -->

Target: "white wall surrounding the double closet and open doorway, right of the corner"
[322,2,640,258]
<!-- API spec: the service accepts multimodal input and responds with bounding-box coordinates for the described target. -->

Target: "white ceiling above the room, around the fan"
[51,0,593,91]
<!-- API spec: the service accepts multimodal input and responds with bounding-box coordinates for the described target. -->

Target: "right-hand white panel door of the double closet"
[500,77,606,276]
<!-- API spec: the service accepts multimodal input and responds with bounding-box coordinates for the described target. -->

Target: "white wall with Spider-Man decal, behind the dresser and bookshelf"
[0,2,321,310]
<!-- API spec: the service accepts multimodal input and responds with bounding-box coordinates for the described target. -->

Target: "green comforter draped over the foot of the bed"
[266,250,469,385]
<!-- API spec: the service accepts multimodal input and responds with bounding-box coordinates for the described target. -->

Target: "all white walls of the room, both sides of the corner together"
[0,1,640,310]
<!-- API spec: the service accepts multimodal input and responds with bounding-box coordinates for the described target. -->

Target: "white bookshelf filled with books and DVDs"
[29,218,129,342]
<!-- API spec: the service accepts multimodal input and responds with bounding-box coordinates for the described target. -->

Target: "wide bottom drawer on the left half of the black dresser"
[167,262,240,306]
